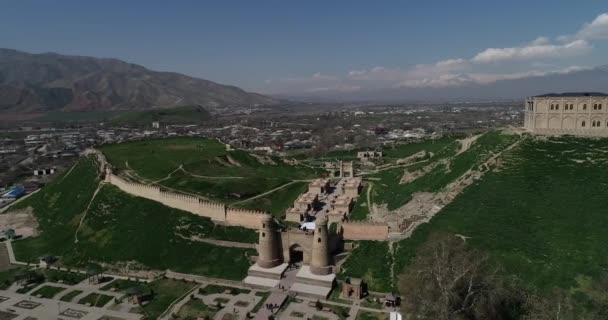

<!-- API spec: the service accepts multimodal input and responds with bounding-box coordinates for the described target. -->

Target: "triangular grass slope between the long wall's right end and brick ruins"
[237,182,308,218]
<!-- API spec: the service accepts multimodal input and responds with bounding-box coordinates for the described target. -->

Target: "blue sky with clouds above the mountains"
[0,0,608,93]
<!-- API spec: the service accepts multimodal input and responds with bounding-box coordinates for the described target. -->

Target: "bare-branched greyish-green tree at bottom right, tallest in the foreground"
[399,235,523,320]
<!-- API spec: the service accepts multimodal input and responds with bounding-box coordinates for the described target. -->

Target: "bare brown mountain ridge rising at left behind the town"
[0,49,277,113]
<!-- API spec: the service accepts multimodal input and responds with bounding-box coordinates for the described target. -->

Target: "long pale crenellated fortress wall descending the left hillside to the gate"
[106,169,265,229]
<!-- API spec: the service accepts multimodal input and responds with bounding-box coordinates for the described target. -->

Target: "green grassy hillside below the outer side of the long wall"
[13,159,257,280]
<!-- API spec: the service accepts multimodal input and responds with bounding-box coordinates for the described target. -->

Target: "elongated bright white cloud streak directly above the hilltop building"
[472,40,591,63]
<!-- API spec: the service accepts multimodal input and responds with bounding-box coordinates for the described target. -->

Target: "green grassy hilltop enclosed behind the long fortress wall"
[101,137,319,203]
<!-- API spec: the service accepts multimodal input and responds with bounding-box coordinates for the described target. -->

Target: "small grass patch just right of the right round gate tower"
[338,241,393,292]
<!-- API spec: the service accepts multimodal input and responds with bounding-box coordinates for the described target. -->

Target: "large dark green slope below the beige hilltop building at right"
[395,137,608,290]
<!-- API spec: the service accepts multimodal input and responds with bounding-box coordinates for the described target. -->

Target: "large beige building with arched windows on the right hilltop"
[524,92,608,136]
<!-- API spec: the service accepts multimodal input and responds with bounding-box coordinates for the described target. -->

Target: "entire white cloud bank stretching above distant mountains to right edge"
[268,13,608,93]
